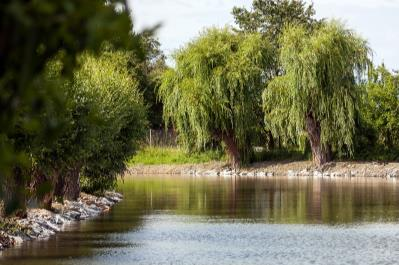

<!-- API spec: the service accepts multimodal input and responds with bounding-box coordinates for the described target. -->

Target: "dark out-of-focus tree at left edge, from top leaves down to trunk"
[0,0,144,213]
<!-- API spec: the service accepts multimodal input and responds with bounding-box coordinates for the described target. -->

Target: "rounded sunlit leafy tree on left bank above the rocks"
[33,48,147,208]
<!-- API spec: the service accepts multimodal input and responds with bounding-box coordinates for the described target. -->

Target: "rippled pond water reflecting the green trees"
[0,176,399,265]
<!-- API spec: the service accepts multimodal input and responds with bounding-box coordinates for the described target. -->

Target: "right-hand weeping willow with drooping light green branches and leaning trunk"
[263,21,370,165]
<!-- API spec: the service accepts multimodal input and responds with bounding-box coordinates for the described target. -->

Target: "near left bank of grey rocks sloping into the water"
[0,192,123,251]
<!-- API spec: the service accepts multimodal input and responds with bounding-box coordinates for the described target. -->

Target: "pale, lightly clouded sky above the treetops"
[129,0,399,70]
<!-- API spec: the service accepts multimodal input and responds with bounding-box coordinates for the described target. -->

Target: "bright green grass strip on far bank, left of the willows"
[128,147,226,165]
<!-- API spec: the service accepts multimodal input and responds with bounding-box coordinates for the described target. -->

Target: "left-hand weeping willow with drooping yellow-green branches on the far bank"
[159,28,271,167]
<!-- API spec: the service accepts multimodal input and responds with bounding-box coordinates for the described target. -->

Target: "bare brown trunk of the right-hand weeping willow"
[306,112,331,166]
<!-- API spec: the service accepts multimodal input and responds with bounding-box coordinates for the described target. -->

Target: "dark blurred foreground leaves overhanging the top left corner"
[0,0,137,171]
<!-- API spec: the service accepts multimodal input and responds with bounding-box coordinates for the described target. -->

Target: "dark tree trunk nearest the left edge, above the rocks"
[4,167,26,217]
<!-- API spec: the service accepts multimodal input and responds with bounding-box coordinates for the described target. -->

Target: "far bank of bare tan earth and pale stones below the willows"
[125,161,399,178]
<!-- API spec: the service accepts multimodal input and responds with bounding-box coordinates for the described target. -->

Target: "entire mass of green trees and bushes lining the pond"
[0,0,399,220]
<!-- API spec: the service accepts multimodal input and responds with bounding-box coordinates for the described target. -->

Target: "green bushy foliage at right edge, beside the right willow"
[356,65,399,160]
